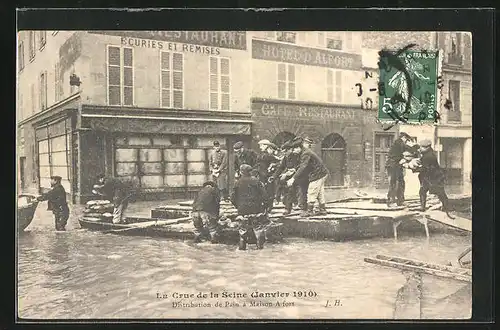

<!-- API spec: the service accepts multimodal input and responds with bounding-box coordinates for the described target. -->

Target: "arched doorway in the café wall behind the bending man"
[321,133,346,186]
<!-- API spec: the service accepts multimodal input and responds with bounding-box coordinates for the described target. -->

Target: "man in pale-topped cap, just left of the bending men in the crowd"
[257,140,279,212]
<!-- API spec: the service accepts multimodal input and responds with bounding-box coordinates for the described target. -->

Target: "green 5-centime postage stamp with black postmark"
[378,49,442,124]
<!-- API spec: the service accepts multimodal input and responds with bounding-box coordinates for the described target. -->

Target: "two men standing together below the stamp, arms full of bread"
[386,132,451,216]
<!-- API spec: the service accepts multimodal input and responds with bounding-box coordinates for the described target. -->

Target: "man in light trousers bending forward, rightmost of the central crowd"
[288,143,329,216]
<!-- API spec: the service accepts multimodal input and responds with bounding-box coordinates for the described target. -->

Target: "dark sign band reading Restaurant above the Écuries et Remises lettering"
[89,31,247,50]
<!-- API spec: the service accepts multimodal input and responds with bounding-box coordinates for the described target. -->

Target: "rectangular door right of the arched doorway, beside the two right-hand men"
[373,133,394,188]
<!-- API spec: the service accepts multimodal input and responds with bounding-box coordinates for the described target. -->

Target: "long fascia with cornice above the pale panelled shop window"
[82,114,252,135]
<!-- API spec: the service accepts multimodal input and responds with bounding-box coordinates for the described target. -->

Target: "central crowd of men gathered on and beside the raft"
[193,137,329,250]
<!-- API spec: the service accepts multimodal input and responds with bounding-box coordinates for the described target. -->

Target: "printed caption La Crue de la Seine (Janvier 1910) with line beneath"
[156,290,341,308]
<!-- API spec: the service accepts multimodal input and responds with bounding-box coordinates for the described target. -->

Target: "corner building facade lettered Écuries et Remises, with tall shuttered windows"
[18,31,251,203]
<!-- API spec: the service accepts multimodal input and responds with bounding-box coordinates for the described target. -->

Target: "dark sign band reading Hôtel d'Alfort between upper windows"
[252,39,361,70]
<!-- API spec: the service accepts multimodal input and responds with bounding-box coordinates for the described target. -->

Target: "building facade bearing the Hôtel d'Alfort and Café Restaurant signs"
[252,31,397,187]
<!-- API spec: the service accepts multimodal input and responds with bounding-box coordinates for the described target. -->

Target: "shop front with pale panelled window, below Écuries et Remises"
[76,105,251,201]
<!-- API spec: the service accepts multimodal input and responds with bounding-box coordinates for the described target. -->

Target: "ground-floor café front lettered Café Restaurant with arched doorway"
[252,98,396,187]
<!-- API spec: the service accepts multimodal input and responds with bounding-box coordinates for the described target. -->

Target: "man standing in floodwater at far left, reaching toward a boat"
[37,176,69,231]
